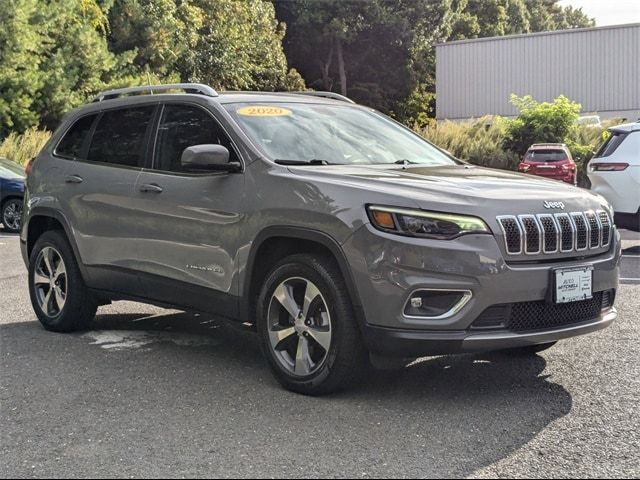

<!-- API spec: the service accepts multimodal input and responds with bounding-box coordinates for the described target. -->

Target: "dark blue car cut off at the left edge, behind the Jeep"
[0,158,25,233]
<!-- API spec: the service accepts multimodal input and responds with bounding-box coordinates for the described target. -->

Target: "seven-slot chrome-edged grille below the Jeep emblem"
[498,210,613,255]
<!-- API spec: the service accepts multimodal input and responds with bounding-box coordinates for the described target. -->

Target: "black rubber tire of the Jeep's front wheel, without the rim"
[256,255,357,395]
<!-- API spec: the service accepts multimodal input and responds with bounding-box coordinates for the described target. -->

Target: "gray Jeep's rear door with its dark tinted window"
[56,104,156,295]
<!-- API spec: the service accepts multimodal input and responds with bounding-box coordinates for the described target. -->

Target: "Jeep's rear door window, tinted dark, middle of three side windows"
[87,105,155,167]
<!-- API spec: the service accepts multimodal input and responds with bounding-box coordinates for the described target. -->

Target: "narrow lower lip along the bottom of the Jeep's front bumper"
[363,308,618,357]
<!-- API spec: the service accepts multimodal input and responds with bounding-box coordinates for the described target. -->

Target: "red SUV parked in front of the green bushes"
[518,143,578,185]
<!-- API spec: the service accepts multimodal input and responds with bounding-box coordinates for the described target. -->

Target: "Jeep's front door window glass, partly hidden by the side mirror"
[154,105,237,173]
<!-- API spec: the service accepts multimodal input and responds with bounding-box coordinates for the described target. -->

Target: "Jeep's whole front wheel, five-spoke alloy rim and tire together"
[257,254,367,395]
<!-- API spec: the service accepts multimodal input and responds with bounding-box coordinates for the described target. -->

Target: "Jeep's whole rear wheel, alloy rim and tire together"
[29,230,98,332]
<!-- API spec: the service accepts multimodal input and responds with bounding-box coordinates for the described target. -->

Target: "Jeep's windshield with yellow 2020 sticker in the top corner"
[225,103,458,166]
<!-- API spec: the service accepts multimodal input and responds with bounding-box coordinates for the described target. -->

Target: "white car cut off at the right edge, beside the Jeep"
[588,121,640,232]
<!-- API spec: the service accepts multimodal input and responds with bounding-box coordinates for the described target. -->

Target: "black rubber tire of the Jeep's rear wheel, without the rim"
[29,230,98,333]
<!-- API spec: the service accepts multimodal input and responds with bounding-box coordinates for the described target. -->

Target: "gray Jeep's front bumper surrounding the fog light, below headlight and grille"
[343,225,621,356]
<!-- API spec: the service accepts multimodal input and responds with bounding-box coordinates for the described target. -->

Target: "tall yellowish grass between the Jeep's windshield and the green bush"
[417,117,519,170]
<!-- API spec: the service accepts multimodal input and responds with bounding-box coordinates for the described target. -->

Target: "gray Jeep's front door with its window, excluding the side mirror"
[134,103,244,317]
